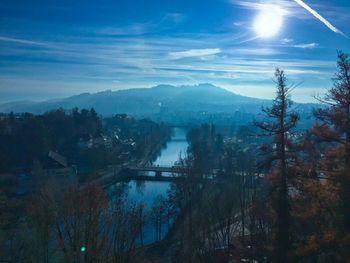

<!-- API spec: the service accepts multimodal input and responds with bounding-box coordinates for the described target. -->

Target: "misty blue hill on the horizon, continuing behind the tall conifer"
[0,84,313,126]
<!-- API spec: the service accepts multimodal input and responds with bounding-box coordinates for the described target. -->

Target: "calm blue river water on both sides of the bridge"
[108,128,188,244]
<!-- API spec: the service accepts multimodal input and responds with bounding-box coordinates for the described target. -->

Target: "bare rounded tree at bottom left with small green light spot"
[55,185,109,263]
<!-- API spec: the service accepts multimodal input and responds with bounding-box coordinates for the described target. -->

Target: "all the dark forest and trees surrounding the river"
[0,52,350,263]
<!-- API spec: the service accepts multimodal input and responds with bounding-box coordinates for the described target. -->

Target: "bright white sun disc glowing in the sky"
[254,5,284,38]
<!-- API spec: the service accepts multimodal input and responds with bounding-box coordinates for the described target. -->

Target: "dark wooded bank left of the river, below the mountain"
[0,109,169,172]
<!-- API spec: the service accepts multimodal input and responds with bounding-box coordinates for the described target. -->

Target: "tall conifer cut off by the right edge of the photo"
[314,51,350,257]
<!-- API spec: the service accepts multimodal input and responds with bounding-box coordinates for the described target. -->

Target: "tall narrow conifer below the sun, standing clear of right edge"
[256,69,299,263]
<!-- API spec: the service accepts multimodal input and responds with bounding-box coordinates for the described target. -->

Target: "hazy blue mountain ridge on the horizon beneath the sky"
[0,84,262,113]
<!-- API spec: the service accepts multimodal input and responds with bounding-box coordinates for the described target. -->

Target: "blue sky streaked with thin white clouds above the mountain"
[0,0,350,102]
